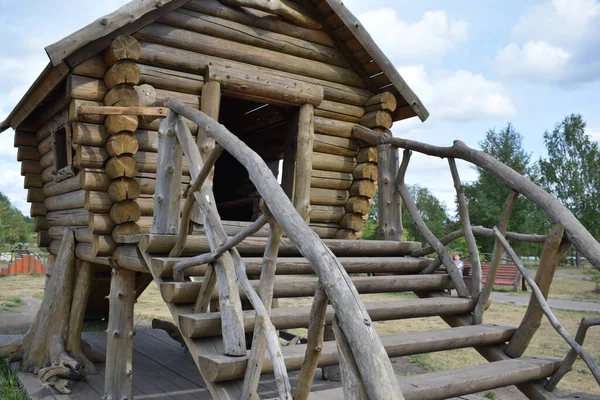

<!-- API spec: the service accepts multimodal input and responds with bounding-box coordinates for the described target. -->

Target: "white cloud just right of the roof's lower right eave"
[399,65,517,121]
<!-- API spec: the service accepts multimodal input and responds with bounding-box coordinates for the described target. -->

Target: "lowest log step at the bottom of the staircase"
[398,357,562,400]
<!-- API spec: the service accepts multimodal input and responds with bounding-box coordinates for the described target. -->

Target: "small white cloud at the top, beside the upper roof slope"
[359,8,468,63]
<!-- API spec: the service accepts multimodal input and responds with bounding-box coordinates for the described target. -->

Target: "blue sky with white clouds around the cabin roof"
[0,0,600,215]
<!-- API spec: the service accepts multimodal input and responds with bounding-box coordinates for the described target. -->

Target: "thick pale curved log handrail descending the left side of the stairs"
[166,99,403,400]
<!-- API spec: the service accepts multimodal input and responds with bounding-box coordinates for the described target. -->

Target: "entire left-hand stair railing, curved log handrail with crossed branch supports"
[152,99,406,400]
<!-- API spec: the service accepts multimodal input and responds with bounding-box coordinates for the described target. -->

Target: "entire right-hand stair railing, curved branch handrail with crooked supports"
[353,125,600,390]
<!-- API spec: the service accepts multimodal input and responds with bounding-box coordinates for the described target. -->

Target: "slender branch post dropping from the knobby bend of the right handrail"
[448,158,483,312]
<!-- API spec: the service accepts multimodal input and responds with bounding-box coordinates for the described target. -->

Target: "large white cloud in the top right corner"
[495,0,600,84]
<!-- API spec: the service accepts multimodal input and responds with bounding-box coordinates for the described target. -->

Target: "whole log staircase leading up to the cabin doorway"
[140,235,562,399]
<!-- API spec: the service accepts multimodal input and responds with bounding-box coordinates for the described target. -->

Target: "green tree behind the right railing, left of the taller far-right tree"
[464,123,548,253]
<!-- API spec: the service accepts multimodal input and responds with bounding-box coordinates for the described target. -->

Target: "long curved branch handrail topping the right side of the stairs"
[352,125,600,270]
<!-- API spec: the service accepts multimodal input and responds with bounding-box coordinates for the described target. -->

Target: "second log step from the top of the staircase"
[152,257,431,278]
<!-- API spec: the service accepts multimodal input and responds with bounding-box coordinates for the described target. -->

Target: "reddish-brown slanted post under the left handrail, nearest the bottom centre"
[294,285,327,400]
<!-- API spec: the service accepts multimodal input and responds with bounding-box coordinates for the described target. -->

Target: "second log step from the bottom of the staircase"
[199,325,515,382]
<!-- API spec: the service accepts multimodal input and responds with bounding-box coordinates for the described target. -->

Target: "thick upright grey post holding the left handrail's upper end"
[150,112,183,235]
